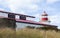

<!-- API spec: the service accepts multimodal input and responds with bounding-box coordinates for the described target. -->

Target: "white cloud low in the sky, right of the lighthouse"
[49,14,60,28]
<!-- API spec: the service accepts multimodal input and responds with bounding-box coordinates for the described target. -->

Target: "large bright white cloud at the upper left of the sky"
[6,0,42,12]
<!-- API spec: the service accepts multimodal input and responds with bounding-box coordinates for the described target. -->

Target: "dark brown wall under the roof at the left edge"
[0,18,16,29]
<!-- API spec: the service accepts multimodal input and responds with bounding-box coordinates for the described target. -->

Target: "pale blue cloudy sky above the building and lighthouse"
[0,0,60,28]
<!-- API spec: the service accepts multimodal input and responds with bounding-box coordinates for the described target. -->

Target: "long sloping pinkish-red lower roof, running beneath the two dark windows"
[0,16,57,27]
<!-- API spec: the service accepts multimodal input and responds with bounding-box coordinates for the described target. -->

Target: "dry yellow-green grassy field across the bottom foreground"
[0,29,60,38]
